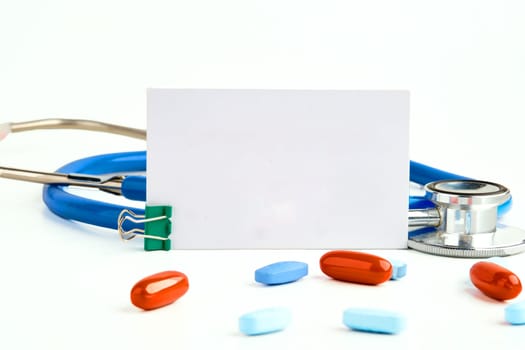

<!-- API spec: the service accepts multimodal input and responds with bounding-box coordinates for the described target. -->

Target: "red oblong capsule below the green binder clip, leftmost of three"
[131,271,189,310]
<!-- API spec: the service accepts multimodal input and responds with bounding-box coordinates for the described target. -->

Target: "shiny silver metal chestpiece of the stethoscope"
[408,180,525,258]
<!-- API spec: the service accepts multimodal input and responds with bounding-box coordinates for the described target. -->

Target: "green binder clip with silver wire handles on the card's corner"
[117,205,172,251]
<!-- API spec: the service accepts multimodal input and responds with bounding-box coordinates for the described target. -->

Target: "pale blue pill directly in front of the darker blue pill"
[239,307,292,335]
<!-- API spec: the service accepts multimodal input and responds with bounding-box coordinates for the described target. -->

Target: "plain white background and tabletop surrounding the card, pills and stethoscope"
[0,0,525,349]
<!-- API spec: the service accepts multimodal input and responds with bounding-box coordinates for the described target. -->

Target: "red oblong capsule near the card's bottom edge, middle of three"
[320,250,392,284]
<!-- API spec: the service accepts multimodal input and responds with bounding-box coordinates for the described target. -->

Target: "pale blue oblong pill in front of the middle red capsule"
[343,308,406,334]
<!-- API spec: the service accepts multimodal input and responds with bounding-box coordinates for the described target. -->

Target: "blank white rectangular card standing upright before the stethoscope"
[147,89,409,249]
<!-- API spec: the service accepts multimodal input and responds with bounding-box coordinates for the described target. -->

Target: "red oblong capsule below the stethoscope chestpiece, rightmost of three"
[470,261,521,300]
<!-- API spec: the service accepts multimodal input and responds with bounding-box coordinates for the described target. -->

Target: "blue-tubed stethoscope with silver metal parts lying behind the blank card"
[0,119,525,257]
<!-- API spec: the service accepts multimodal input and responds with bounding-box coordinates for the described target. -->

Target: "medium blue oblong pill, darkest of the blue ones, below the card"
[255,261,308,285]
